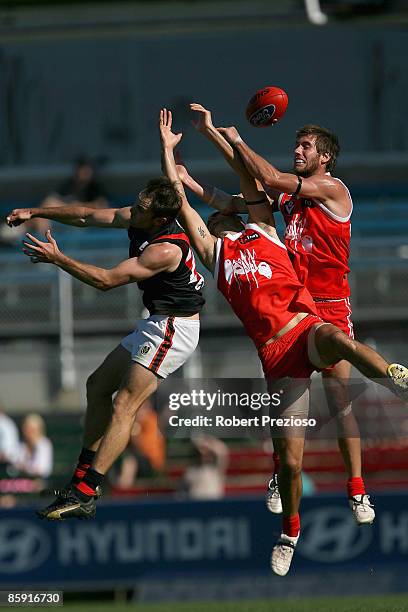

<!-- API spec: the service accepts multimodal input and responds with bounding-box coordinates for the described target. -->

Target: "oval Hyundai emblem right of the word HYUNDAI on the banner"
[298,507,373,563]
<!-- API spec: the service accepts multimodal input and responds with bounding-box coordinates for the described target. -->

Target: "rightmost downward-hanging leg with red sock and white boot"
[322,360,375,525]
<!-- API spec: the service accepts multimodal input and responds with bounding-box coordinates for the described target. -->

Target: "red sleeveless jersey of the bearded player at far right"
[278,179,353,298]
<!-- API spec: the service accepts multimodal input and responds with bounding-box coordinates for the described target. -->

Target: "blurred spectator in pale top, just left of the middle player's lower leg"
[183,435,228,499]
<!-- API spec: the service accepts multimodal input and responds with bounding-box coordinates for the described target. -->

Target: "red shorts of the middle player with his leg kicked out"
[258,315,322,379]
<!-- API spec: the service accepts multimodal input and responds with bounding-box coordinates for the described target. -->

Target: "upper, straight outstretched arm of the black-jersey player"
[6,206,131,228]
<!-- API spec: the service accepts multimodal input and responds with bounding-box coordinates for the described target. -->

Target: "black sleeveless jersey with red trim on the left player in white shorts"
[128,221,205,315]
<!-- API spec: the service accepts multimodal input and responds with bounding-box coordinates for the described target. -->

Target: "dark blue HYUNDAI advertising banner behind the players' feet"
[0,495,408,589]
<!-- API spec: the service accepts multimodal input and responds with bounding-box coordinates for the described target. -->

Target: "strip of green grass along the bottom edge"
[35,594,408,612]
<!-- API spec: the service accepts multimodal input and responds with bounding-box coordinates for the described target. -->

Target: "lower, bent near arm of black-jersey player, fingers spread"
[23,230,182,291]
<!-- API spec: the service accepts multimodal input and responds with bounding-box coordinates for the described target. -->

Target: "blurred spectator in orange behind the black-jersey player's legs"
[117,401,166,489]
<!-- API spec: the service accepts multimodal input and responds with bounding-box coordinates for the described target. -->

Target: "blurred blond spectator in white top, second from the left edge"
[15,414,53,478]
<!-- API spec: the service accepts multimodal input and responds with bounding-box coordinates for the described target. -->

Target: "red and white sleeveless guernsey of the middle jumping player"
[214,223,316,348]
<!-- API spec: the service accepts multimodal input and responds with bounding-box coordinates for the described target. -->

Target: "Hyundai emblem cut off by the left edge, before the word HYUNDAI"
[0,519,51,574]
